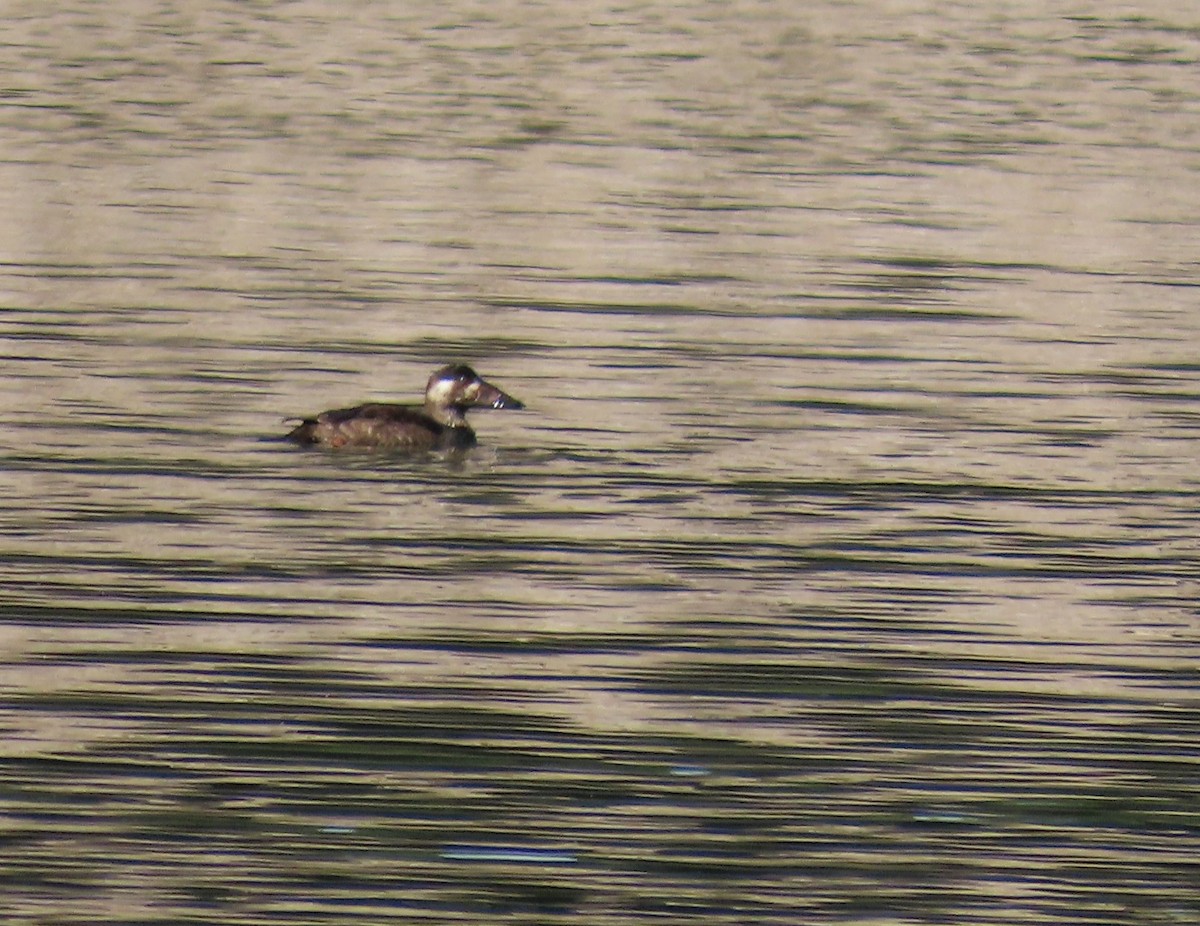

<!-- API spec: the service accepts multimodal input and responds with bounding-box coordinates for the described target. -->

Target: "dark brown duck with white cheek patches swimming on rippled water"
[284,363,524,453]
